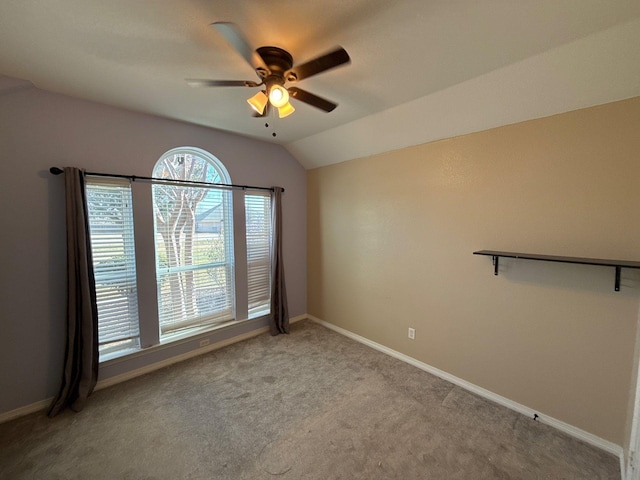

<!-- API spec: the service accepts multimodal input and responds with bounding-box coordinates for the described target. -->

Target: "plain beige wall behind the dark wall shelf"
[307,97,640,445]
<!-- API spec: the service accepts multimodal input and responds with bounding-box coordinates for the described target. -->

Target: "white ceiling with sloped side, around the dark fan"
[0,0,640,168]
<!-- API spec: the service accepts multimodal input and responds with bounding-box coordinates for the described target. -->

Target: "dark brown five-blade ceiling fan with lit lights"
[187,22,351,118]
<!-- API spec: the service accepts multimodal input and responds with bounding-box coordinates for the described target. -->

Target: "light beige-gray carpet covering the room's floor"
[0,321,620,480]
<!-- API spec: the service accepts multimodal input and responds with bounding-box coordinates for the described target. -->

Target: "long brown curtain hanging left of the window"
[49,167,98,417]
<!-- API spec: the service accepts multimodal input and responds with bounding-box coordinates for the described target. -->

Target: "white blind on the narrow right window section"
[245,192,271,318]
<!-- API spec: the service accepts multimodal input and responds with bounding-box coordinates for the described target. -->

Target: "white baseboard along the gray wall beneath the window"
[0,314,308,423]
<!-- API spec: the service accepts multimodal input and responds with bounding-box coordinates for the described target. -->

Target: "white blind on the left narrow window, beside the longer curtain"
[86,178,140,360]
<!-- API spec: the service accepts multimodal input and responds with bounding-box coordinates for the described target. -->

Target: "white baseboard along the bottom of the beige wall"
[307,315,624,462]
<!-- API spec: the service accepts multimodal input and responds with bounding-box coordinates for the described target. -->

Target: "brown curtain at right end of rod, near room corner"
[269,187,289,335]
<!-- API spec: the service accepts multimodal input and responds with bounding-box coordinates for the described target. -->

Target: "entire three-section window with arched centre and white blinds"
[86,147,271,362]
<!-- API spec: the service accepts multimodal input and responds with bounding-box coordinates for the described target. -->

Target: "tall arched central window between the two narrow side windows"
[153,147,235,339]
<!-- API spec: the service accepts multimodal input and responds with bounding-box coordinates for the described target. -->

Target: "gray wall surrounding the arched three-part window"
[0,84,306,414]
